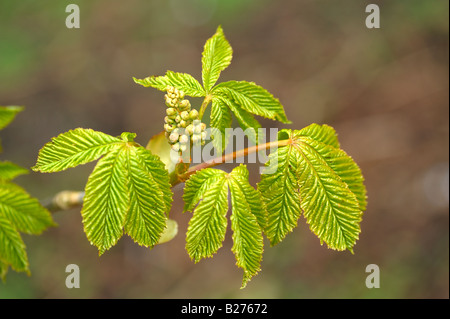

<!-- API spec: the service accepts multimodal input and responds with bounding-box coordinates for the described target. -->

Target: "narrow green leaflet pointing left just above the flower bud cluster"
[133,71,205,97]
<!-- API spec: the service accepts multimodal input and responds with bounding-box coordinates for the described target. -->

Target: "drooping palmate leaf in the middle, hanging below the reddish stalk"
[183,165,266,288]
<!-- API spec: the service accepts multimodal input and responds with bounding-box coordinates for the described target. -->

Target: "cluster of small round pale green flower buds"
[164,86,206,152]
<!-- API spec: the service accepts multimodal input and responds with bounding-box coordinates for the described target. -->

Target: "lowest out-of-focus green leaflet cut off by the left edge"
[0,214,30,275]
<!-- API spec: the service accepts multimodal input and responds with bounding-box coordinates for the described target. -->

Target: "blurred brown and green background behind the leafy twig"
[0,0,449,298]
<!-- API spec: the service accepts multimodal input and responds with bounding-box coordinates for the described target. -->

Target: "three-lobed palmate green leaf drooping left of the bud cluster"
[33,129,172,254]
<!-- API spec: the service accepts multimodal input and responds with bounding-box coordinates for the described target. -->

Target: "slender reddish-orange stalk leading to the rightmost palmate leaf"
[172,139,292,187]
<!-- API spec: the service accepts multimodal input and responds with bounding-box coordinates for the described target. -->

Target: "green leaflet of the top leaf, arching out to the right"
[213,81,291,123]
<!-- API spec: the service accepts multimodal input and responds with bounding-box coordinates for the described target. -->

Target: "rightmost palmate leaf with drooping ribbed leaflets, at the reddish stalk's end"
[258,124,366,251]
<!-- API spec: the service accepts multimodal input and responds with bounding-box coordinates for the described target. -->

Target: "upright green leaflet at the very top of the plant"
[202,26,233,94]
